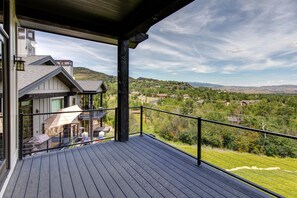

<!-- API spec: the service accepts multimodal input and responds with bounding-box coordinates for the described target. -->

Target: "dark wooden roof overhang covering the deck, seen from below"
[15,0,193,48]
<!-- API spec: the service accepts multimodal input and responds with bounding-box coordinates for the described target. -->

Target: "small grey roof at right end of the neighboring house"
[76,80,106,93]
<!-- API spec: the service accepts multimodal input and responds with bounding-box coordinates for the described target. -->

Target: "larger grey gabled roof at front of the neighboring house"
[18,65,83,97]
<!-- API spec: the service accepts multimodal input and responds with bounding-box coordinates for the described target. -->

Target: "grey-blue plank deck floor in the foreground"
[5,136,268,198]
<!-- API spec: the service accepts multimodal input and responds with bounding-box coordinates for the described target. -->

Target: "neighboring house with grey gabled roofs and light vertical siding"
[0,56,106,138]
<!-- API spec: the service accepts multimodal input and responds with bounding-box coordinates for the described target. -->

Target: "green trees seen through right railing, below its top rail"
[145,110,297,158]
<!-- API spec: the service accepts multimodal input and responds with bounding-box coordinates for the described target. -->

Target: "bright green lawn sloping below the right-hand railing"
[145,131,297,197]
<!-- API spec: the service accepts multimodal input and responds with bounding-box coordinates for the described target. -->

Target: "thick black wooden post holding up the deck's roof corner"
[118,39,129,142]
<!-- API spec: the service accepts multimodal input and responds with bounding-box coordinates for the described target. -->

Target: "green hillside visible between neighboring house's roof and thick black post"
[73,67,117,82]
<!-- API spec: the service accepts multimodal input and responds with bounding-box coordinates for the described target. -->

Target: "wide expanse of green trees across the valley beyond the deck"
[104,78,297,157]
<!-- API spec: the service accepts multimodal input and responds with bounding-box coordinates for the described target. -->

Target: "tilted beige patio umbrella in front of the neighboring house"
[44,105,82,129]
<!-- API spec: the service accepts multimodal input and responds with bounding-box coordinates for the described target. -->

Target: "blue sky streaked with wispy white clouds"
[36,0,297,86]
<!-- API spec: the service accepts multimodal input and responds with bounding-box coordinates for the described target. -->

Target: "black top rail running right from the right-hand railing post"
[201,118,297,140]
